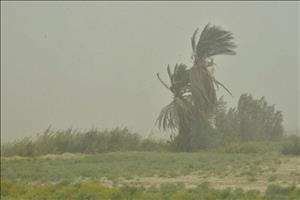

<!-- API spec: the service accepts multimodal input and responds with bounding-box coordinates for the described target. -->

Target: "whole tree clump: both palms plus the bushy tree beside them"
[157,24,284,152]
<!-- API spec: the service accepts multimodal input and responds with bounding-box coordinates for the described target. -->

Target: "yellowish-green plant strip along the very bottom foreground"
[1,181,300,200]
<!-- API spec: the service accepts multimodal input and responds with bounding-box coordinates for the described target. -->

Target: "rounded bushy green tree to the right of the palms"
[215,94,283,144]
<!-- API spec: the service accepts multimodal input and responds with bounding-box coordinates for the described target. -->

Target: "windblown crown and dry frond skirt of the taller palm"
[190,24,236,116]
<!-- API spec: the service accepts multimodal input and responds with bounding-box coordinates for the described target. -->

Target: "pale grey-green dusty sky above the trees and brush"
[1,1,299,142]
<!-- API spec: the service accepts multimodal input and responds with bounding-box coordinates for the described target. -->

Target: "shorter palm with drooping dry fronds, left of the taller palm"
[157,64,193,151]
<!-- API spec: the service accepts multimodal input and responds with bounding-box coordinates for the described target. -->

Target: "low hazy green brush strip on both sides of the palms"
[1,124,300,157]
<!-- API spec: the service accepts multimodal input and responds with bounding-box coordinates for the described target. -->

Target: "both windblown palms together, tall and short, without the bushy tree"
[157,24,236,150]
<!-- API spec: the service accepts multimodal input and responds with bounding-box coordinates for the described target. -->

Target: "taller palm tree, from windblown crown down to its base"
[190,24,236,149]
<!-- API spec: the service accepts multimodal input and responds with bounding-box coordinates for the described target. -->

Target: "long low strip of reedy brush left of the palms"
[1,128,168,156]
